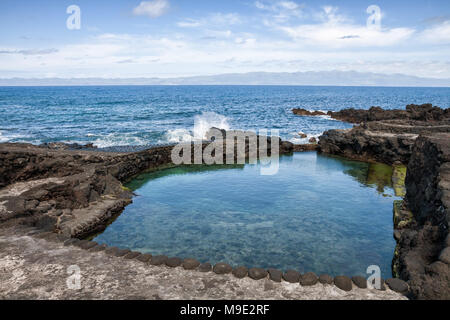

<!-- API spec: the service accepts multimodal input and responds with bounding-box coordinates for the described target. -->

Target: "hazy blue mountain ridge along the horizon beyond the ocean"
[0,71,450,87]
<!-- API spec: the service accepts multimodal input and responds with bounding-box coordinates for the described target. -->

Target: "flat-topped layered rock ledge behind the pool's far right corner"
[319,104,450,165]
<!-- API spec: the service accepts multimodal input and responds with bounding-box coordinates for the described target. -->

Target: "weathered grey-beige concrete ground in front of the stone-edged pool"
[0,228,406,300]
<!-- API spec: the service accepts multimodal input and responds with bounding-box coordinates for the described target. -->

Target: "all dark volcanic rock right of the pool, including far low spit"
[293,104,450,299]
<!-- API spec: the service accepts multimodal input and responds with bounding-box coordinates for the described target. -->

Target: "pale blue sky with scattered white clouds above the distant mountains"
[0,0,450,78]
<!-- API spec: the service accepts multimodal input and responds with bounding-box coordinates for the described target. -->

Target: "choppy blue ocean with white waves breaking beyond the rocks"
[0,86,450,148]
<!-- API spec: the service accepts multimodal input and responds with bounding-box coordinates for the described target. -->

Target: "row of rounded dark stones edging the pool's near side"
[30,232,409,295]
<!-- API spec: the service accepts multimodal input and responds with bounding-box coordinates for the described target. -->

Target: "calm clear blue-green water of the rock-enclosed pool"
[95,152,402,277]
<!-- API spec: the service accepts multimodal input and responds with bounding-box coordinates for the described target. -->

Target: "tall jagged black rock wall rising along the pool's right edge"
[393,133,450,300]
